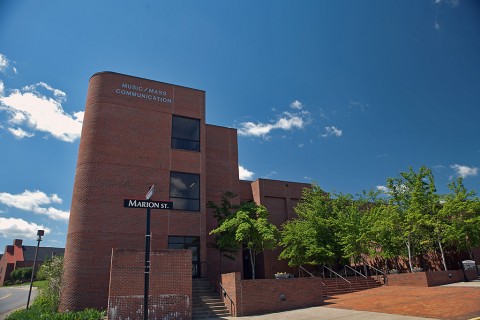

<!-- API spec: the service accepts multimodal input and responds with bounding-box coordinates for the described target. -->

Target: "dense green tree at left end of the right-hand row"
[280,185,342,266]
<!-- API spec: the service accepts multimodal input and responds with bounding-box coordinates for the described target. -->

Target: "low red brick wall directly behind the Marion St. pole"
[108,250,192,320]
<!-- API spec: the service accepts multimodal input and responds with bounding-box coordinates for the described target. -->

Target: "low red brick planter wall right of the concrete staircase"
[222,273,324,316]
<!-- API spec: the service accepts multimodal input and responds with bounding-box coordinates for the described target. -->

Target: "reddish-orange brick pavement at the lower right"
[325,286,480,320]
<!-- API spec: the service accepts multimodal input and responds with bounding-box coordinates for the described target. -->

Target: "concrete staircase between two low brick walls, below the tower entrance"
[192,278,230,320]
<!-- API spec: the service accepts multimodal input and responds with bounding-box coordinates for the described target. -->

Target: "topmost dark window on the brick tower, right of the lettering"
[172,116,200,151]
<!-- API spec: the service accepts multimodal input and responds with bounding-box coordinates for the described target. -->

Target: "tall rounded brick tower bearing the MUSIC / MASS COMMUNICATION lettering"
[60,72,212,310]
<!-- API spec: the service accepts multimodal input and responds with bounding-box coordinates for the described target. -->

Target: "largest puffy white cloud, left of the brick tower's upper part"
[0,82,84,142]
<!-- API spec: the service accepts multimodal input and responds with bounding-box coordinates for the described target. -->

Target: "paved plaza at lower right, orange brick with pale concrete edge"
[227,281,480,320]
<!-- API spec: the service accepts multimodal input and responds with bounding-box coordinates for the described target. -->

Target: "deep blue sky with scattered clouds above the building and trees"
[0,0,480,252]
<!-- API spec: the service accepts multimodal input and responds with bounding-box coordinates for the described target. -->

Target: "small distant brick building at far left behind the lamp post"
[0,239,65,286]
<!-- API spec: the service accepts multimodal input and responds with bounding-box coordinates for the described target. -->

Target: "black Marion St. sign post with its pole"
[123,185,173,320]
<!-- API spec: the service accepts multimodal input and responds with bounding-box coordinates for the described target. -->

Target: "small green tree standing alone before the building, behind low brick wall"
[210,202,278,279]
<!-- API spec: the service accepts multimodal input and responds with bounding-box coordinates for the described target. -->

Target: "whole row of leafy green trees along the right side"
[280,166,480,272]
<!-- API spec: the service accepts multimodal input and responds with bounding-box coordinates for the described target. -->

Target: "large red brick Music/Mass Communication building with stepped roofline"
[60,72,308,313]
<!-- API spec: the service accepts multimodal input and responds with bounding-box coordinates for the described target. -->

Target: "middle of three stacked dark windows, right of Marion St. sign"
[170,172,200,211]
